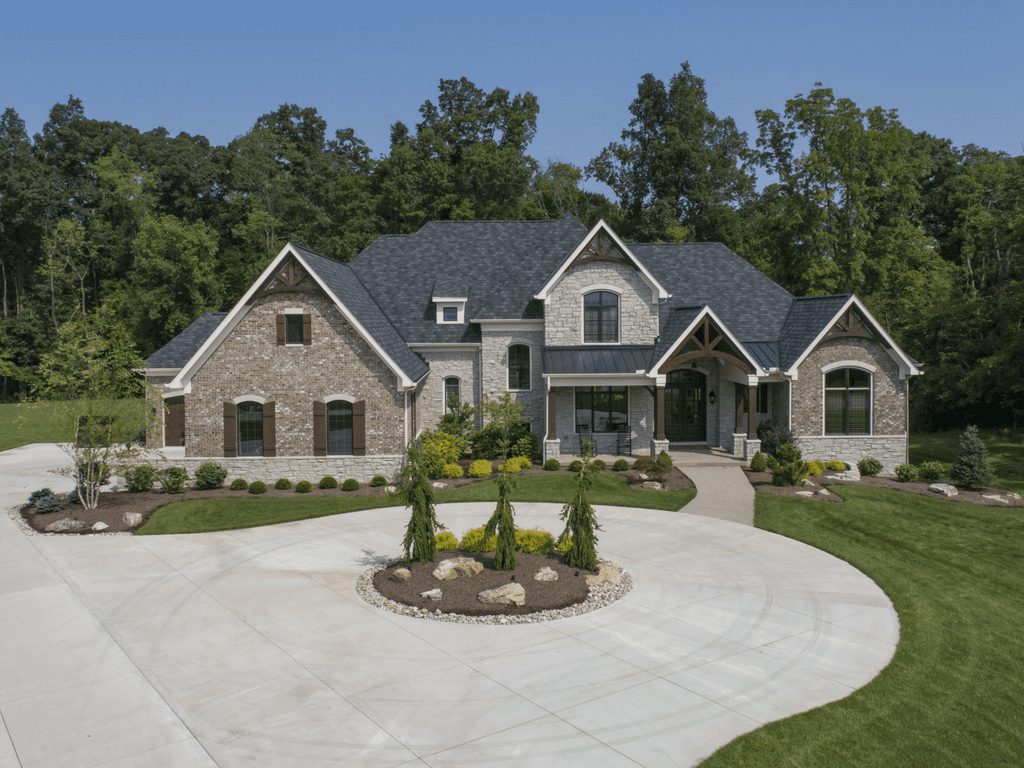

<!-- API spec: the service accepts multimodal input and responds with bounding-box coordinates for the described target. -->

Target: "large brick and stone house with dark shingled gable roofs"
[144,216,921,479]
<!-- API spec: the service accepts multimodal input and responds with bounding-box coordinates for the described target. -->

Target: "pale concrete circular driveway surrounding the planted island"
[0,446,898,768]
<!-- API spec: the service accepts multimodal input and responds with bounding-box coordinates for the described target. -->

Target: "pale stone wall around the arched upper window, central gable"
[544,261,658,346]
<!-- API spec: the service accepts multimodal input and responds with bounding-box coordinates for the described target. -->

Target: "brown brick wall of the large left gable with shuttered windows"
[185,293,406,461]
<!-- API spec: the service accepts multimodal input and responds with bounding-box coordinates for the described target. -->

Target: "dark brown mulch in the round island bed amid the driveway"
[374,552,588,615]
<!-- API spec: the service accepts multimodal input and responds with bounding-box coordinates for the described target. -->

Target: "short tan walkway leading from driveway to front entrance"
[670,449,754,525]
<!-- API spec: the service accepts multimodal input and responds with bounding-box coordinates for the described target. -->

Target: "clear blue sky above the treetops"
[0,0,1024,185]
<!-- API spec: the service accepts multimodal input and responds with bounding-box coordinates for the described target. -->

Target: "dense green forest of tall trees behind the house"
[0,63,1024,429]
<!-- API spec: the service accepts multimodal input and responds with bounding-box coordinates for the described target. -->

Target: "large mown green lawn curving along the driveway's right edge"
[702,486,1024,768]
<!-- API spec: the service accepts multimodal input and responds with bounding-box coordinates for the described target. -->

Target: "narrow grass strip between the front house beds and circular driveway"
[136,472,696,536]
